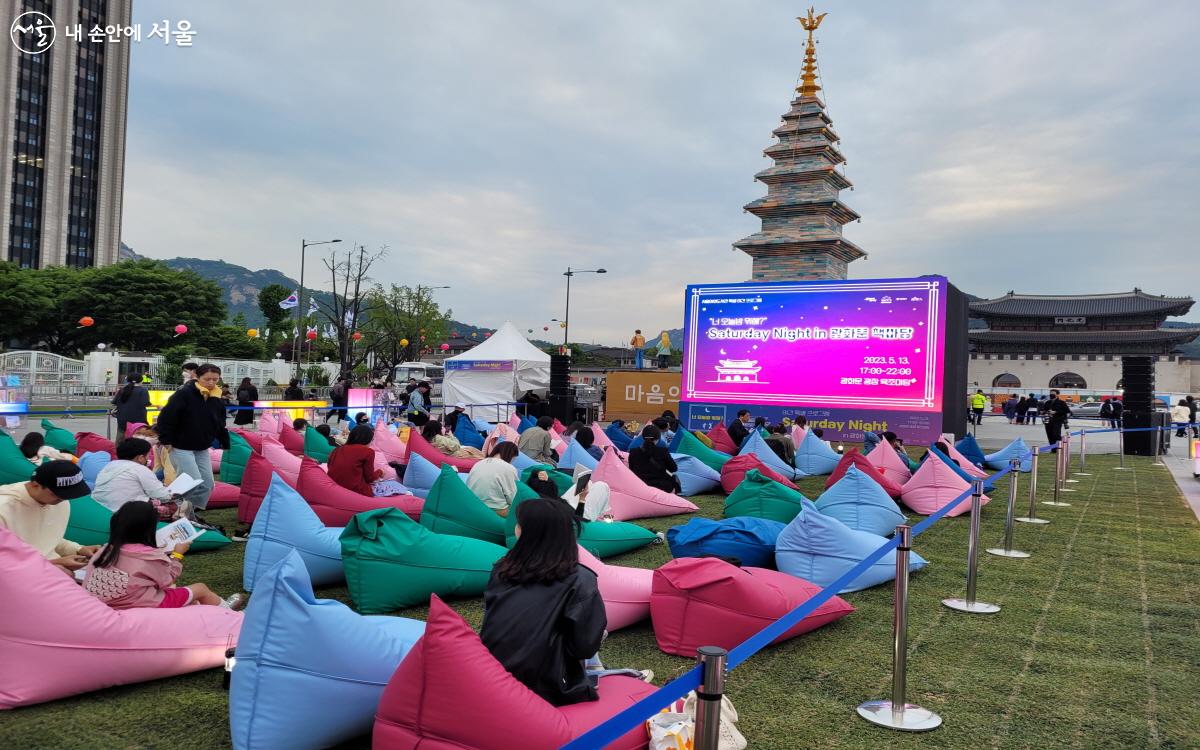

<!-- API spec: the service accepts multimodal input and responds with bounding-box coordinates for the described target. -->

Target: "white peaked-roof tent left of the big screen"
[442,323,550,421]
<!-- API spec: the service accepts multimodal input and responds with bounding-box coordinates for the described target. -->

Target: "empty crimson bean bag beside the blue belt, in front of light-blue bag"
[650,557,854,658]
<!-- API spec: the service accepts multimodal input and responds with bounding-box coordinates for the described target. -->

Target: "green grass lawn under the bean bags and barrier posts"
[0,456,1200,750]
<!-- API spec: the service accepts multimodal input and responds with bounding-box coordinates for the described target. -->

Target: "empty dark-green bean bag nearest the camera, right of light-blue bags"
[342,508,505,613]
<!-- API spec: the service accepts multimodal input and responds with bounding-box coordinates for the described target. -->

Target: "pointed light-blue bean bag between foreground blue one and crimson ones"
[241,474,346,592]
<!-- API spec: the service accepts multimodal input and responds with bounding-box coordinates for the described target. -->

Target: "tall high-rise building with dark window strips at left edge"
[0,0,132,268]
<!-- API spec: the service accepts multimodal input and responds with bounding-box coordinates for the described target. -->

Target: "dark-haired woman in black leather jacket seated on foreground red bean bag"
[479,498,654,706]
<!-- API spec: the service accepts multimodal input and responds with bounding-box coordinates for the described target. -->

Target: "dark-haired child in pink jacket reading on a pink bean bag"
[83,502,245,610]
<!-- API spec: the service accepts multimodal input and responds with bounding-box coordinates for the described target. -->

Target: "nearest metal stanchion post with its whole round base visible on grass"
[859,526,942,729]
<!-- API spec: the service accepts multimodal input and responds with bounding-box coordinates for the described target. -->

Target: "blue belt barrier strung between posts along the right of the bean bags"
[562,452,1032,750]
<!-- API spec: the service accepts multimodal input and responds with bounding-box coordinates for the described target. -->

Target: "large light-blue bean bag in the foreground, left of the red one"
[229,547,425,750]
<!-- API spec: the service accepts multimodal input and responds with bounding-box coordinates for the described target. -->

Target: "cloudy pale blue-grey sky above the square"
[124,0,1200,343]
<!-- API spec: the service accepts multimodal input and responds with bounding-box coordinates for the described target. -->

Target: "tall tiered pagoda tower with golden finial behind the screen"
[733,8,866,281]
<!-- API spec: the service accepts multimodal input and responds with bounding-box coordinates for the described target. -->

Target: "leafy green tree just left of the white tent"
[362,284,452,373]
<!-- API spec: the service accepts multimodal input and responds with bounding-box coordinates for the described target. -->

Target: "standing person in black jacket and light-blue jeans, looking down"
[156,364,229,510]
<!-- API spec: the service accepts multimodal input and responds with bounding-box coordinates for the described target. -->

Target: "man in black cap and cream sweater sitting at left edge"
[0,461,100,575]
